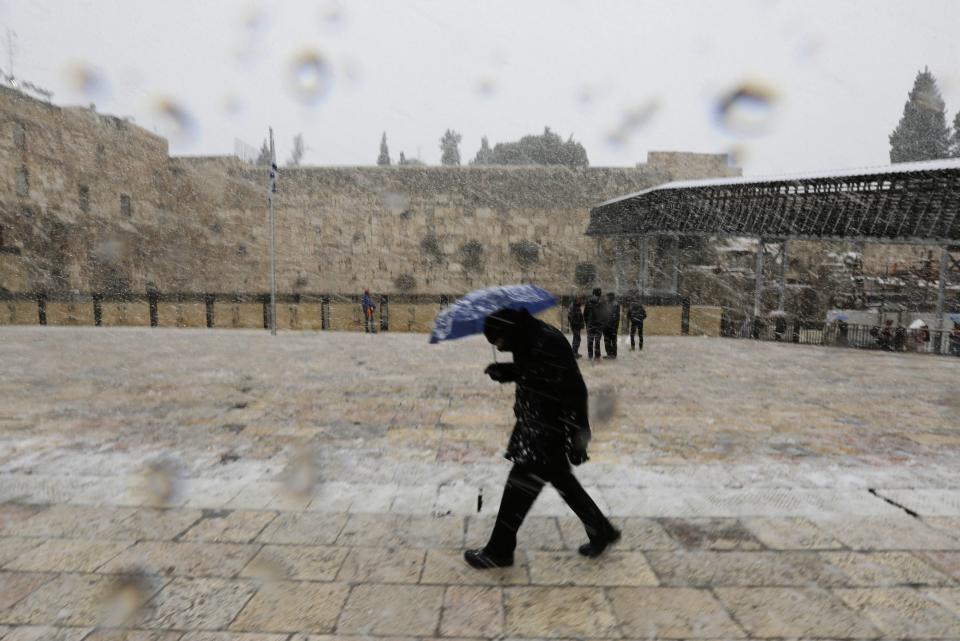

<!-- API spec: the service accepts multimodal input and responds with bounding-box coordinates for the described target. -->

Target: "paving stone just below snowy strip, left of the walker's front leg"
[337,514,463,548]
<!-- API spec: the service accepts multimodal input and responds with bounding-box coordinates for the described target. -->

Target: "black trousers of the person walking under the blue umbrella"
[484,464,613,557]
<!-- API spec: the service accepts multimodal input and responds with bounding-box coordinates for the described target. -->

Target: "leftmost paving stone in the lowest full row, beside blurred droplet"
[0,574,163,626]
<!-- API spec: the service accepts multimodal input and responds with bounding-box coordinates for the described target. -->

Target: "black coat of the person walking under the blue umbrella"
[492,317,590,466]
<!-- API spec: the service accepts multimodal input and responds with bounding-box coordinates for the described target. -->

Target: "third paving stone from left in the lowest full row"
[230,581,349,633]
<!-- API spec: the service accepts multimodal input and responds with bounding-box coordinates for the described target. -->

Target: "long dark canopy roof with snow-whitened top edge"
[587,159,960,243]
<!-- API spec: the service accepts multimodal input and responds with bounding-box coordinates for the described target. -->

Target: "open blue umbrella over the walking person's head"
[430,285,557,343]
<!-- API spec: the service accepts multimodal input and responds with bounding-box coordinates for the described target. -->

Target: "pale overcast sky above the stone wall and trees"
[0,0,960,175]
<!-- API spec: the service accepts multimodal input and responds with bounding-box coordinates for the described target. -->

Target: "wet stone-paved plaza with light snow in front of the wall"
[0,327,960,641]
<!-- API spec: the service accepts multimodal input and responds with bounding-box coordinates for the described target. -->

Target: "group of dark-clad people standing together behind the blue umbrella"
[567,287,647,361]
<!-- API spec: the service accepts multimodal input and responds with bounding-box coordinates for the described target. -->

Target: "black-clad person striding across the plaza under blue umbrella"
[464,309,620,569]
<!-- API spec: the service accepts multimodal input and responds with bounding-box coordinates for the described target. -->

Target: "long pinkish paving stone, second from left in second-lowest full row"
[100,541,260,577]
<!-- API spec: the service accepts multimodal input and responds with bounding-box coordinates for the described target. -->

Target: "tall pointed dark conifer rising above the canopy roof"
[890,67,950,163]
